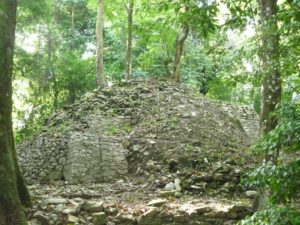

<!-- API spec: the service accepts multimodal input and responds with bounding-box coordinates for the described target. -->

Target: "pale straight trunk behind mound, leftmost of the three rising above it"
[96,0,105,87]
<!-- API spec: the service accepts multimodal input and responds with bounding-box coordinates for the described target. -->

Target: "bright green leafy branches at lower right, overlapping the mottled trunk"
[241,102,300,225]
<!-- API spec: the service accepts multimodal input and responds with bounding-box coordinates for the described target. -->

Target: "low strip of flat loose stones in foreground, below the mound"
[30,178,256,225]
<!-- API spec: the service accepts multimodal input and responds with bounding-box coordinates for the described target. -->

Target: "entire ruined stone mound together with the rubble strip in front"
[18,80,258,225]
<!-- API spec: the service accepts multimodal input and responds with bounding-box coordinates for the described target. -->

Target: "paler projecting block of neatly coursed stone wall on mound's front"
[64,115,127,183]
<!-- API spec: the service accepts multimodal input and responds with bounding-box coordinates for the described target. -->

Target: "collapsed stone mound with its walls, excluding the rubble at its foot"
[17,80,258,184]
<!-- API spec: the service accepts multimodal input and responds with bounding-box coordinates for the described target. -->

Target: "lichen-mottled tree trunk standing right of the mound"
[260,0,281,164]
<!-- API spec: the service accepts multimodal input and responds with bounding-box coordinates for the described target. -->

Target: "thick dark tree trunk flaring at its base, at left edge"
[0,0,27,225]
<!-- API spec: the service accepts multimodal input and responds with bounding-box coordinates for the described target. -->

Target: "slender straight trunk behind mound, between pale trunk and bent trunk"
[125,0,134,80]
